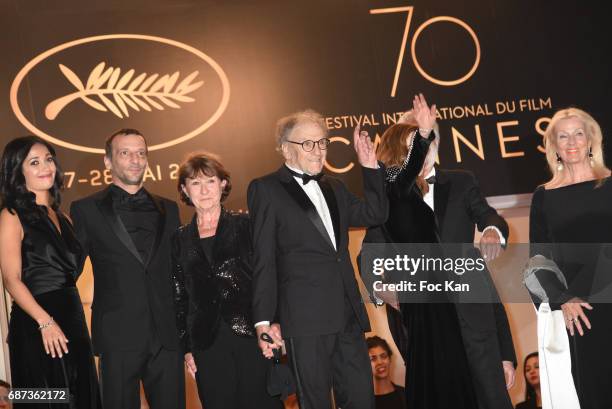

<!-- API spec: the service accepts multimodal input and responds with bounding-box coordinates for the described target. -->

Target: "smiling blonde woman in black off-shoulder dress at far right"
[529,108,612,409]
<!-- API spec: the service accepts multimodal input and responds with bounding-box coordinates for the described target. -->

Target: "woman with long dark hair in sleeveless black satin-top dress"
[0,136,101,409]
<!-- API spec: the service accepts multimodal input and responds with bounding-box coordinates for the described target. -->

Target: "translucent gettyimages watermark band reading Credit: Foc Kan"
[359,243,612,303]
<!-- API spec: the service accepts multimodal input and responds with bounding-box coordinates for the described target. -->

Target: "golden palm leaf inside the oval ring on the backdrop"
[45,62,204,120]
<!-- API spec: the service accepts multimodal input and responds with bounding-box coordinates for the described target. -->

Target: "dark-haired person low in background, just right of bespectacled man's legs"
[366,336,406,409]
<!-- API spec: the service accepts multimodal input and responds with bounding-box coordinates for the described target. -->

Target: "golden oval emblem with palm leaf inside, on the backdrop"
[9,34,231,154]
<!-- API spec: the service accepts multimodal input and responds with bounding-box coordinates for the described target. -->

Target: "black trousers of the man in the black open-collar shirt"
[99,337,185,409]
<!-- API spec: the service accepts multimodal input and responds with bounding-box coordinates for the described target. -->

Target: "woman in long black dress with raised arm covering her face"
[364,94,478,409]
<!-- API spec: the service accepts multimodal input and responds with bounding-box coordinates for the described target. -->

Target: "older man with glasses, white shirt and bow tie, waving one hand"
[248,111,388,409]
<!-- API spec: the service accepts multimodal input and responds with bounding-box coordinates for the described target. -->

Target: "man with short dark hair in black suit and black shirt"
[70,129,185,409]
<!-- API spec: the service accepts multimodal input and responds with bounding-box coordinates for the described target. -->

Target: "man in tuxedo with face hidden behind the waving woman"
[422,132,516,409]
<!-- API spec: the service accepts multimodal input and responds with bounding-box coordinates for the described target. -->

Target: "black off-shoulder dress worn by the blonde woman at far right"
[529,178,612,409]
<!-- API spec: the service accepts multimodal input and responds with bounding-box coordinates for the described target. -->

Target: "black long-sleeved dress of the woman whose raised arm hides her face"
[364,133,478,409]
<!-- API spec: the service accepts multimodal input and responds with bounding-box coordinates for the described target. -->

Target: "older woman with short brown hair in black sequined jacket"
[172,153,281,409]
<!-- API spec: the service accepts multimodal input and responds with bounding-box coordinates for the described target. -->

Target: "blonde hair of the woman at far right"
[544,108,610,185]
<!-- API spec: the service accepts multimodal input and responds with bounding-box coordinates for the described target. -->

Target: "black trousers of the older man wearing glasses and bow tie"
[286,300,374,409]
